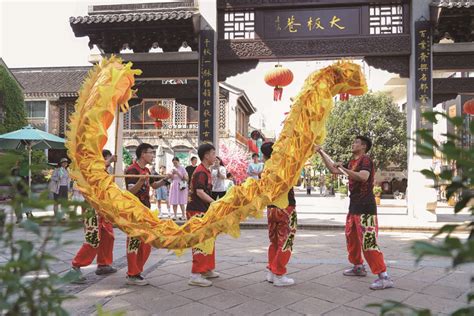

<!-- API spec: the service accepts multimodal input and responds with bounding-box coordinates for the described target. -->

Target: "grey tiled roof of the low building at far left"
[10,66,91,98]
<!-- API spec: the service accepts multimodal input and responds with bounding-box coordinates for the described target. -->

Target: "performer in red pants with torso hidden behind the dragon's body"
[260,142,297,286]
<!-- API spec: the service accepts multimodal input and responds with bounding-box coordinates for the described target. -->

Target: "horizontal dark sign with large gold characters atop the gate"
[264,8,361,39]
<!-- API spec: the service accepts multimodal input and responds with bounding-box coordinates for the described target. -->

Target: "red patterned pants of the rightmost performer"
[346,214,387,274]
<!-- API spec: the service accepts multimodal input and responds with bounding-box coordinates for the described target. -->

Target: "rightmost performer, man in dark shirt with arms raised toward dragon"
[315,136,393,290]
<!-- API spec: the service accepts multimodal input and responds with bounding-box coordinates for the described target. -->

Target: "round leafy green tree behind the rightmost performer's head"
[324,93,407,168]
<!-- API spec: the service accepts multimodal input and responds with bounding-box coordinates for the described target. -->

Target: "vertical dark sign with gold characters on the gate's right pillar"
[415,21,433,129]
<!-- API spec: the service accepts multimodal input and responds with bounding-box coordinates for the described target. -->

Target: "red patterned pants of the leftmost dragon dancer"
[72,211,115,268]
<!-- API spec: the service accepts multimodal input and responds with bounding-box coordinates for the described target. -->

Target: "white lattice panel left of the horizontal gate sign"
[224,11,255,39]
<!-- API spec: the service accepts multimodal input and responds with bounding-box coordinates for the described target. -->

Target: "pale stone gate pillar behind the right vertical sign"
[407,0,436,221]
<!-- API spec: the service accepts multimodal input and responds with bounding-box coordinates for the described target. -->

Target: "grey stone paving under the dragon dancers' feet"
[25,229,466,315]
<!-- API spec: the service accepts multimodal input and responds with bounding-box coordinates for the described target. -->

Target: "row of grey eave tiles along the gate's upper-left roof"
[69,10,196,25]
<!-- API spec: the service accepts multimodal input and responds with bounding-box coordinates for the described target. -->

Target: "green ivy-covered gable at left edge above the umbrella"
[0,64,27,134]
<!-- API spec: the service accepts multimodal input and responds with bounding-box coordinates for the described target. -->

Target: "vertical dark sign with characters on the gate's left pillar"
[198,30,216,143]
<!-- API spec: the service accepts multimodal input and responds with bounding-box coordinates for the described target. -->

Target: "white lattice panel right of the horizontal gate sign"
[369,4,403,34]
